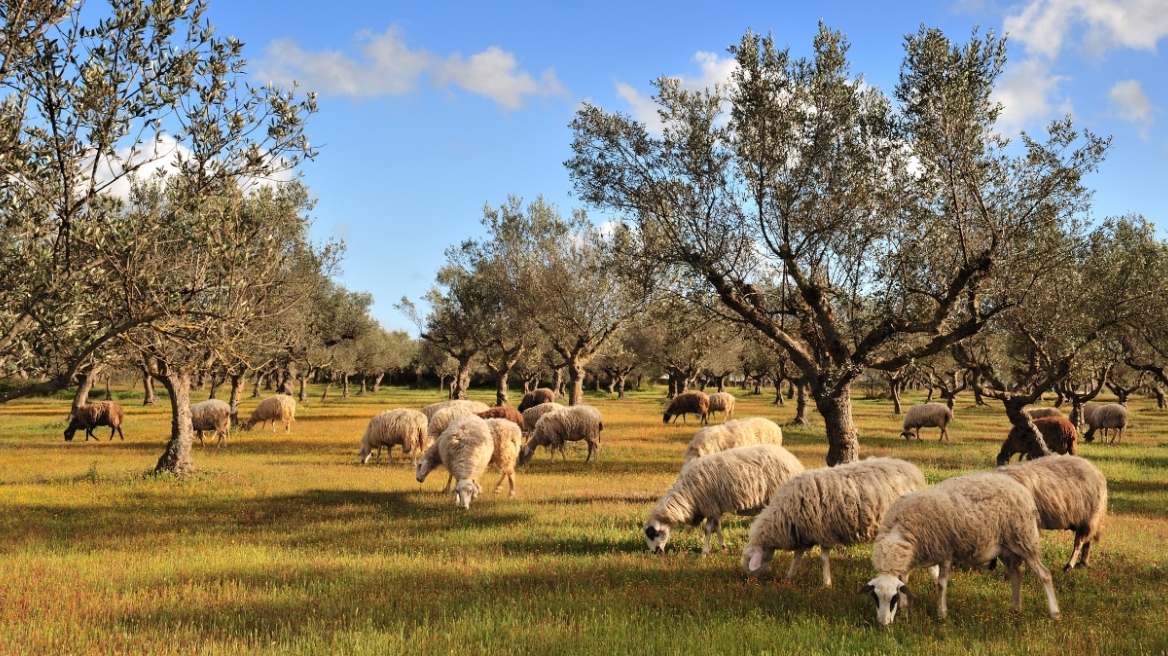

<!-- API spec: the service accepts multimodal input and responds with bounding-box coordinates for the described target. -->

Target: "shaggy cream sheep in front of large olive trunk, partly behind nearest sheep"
[742,458,925,587]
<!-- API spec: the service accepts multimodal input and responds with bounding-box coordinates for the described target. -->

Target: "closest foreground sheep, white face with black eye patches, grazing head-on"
[860,469,1059,626]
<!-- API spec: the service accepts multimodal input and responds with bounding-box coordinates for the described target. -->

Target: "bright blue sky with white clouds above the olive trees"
[210,0,1168,332]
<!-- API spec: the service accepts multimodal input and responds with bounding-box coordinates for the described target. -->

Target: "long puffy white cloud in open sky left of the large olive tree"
[257,27,566,110]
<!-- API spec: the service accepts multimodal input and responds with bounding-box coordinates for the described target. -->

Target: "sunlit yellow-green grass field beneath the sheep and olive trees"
[0,389,1168,655]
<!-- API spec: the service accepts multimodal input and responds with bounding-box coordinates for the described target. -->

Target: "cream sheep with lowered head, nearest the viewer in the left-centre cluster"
[416,414,495,510]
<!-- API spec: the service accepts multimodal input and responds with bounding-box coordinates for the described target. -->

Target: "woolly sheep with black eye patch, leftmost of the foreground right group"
[642,445,804,556]
